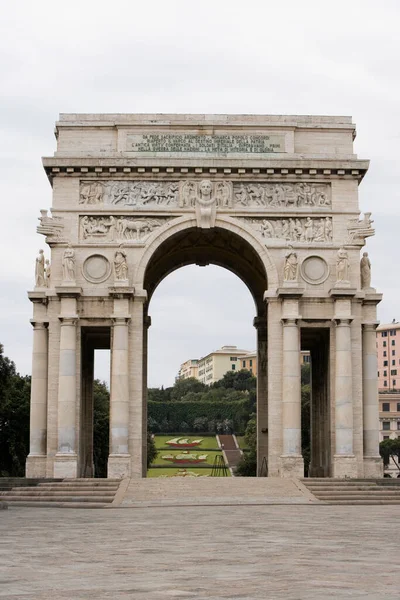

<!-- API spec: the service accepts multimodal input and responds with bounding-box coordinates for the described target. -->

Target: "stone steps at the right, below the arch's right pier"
[301,478,400,504]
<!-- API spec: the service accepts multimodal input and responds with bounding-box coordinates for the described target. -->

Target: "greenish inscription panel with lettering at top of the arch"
[126,133,285,154]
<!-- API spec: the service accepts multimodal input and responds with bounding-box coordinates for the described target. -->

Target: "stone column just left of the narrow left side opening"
[54,317,77,477]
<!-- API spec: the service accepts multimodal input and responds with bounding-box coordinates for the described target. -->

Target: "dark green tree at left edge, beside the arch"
[0,344,31,477]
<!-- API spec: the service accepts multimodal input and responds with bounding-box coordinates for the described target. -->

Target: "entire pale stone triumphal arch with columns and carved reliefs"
[26,114,382,477]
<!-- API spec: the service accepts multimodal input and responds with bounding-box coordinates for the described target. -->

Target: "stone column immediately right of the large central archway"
[282,318,304,477]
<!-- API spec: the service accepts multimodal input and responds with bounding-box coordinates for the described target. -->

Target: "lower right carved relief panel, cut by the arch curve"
[245,217,333,244]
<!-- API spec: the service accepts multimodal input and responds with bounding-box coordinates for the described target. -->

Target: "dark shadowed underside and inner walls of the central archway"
[143,227,268,475]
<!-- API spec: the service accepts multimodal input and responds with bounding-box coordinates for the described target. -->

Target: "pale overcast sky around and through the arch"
[0,0,400,386]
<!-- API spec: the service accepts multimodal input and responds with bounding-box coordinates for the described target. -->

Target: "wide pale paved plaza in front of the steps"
[0,505,400,600]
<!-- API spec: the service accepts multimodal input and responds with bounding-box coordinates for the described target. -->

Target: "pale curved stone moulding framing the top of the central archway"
[133,215,279,290]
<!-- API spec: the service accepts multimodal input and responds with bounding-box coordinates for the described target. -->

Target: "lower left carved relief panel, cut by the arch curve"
[79,215,168,243]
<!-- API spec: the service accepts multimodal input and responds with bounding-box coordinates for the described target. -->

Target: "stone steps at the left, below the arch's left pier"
[0,479,121,508]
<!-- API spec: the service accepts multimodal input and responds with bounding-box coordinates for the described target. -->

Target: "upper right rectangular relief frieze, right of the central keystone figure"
[234,182,332,208]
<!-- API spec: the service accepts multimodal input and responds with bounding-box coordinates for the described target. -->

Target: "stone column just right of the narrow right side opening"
[333,318,357,477]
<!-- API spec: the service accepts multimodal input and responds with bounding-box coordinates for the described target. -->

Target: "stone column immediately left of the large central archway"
[108,314,130,478]
